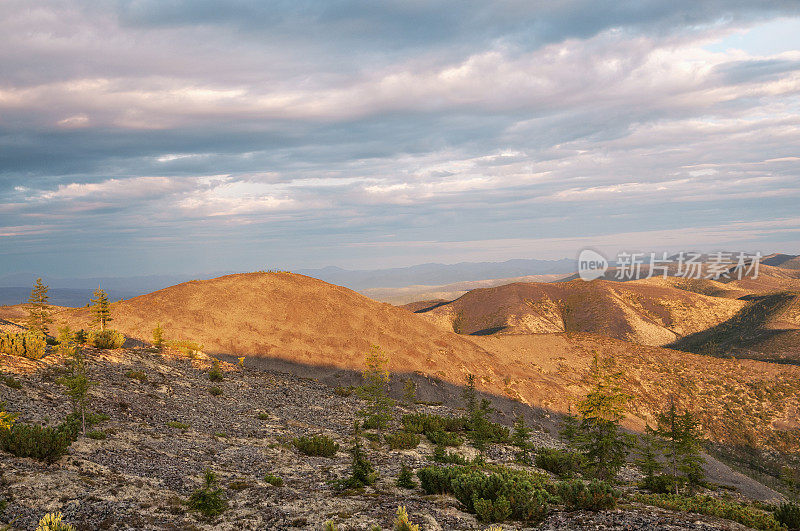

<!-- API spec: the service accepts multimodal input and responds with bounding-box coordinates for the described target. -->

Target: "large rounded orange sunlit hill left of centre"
[53,273,496,376]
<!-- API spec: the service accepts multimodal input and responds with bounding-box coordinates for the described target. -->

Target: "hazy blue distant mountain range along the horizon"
[0,258,576,307]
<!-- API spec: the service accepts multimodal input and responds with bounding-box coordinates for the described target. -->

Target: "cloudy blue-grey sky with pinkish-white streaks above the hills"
[0,0,800,276]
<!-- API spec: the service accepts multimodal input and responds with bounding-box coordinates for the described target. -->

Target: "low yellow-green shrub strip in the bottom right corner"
[634,494,783,531]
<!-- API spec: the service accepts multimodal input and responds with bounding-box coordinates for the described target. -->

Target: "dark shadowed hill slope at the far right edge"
[666,291,800,364]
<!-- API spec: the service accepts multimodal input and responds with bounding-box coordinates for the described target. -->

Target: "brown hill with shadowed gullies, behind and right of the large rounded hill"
[412,280,746,345]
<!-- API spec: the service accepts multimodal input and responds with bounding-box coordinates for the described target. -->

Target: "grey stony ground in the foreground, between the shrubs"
[0,348,784,530]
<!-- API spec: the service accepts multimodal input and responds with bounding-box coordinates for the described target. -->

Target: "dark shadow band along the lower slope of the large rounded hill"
[214,354,566,436]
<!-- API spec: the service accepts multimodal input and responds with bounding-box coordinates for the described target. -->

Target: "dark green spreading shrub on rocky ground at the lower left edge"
[0,423,73,463]
